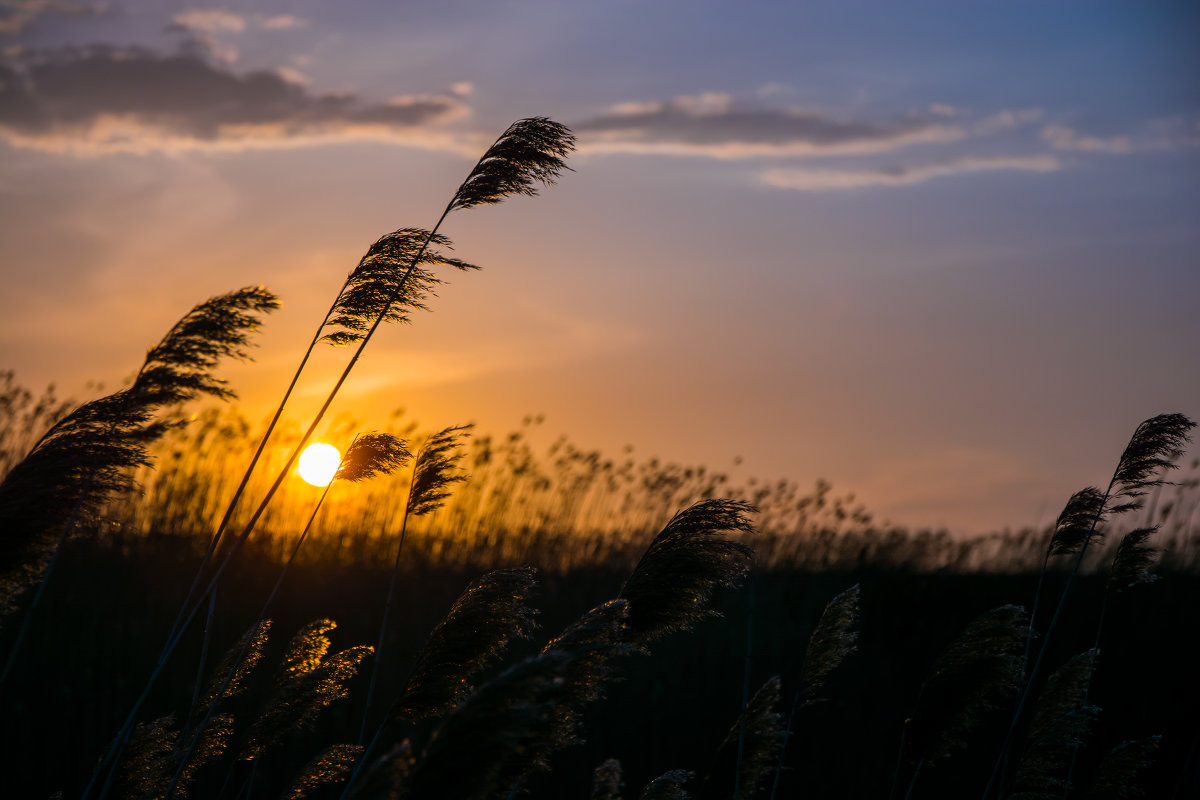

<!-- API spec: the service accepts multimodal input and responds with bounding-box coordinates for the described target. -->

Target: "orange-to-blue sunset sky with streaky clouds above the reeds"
[0,0,1200,533]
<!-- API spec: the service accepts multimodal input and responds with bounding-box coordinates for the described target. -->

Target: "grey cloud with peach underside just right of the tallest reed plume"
[574,92,967,158]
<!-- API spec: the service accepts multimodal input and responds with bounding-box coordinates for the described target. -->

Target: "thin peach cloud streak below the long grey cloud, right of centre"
[760,156,1062,192]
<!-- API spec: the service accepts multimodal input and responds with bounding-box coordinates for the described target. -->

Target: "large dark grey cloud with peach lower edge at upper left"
[0,46,468,152]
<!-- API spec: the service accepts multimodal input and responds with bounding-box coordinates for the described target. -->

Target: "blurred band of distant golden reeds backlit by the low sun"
[0,398,1185,572]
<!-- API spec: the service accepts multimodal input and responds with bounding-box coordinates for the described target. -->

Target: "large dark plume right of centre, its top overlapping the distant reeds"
[618,500,754,645]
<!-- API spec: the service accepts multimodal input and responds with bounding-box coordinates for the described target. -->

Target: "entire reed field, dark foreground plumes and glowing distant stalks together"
[0,118,1200,800]
